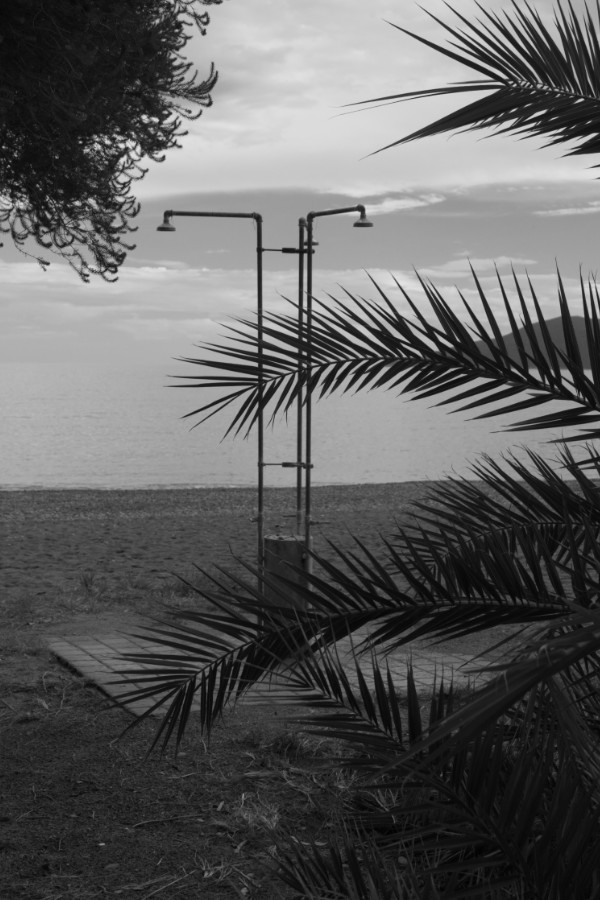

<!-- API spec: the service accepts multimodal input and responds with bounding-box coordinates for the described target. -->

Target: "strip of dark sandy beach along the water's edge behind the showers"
[0,481,440,596]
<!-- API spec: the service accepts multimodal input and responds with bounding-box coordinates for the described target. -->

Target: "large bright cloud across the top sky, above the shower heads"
[138,0,589,198]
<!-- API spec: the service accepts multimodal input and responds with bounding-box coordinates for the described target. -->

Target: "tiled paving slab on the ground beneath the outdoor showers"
[49,623,483,716]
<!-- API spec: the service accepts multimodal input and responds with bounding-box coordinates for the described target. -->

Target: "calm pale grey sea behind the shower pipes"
[0,363,584,488]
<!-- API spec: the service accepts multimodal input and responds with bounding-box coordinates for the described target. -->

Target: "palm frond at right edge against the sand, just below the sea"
[381,448,600,624]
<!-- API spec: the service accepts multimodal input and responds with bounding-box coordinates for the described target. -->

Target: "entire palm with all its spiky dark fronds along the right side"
[118,4,600,900]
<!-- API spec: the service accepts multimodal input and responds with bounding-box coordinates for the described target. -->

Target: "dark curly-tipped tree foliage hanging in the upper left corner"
[0,0,221,280]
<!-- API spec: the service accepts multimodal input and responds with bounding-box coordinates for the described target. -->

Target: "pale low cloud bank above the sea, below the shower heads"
[0,253,422,359]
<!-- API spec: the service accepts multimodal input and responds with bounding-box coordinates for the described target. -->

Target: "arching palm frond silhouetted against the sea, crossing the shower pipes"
[176,272,600,440]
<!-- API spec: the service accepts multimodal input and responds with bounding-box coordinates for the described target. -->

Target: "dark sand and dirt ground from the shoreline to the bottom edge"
[0,485,516,900]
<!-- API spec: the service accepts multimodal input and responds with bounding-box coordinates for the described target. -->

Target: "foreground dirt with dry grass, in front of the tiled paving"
[0,614,360,900]
